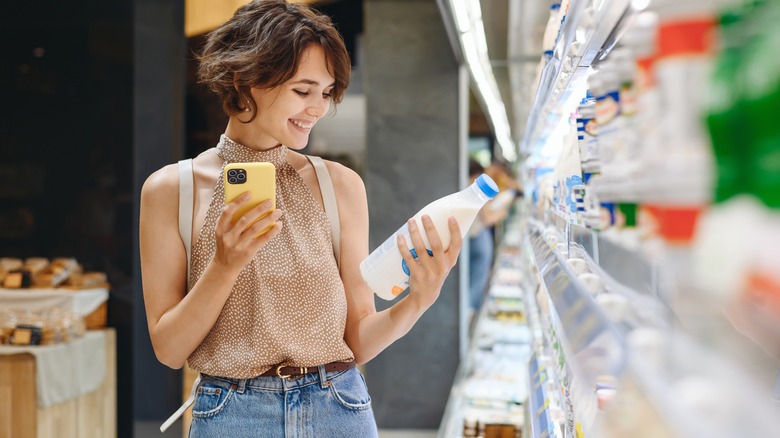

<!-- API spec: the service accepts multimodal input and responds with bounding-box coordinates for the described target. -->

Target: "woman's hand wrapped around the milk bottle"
[397,215,463,309]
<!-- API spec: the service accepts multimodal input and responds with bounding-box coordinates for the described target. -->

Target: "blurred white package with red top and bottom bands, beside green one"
[640,1,717,250]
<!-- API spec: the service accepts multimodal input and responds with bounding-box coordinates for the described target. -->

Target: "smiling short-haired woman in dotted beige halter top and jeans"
[140,0,461,437]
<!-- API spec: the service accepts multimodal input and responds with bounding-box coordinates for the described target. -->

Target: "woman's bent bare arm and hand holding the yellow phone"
[139,165,281,369]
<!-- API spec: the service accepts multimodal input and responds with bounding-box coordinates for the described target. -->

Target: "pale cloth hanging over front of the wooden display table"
[0,330,106,408]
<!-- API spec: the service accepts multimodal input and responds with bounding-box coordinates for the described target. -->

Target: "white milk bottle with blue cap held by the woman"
[360,174,498,300]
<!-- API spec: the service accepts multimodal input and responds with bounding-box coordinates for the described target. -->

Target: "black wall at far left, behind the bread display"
[0,0,133,436]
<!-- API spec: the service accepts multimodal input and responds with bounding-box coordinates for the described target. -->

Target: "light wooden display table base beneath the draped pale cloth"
[0,328,117,438]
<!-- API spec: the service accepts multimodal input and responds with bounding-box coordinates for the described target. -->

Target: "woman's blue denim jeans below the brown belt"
[190,367,378,438]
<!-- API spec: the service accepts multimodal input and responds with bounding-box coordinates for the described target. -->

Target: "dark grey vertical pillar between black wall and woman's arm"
[132,0,187,428]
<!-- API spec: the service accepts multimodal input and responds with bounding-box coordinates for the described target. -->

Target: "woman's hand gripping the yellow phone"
[214,192,282,272]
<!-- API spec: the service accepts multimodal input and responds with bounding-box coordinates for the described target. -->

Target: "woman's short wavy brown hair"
[198,0,351,121]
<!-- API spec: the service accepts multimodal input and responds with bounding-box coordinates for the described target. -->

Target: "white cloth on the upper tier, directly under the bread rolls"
[0,288,108,316]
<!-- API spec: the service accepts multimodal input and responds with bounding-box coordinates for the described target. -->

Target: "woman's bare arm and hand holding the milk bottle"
[328,163,462,363]
